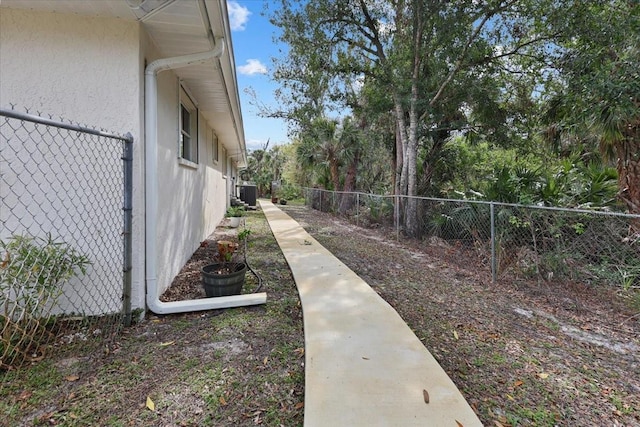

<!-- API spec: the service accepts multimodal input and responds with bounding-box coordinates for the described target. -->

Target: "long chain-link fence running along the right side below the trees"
[304,188,640,289]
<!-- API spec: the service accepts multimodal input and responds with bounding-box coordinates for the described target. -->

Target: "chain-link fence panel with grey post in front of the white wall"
[0,110,133,371]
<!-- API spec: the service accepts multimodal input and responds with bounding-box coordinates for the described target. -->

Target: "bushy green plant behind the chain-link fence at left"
[0,235,90,368]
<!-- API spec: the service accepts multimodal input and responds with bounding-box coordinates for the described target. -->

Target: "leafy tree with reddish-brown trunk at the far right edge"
[546,0,640,224]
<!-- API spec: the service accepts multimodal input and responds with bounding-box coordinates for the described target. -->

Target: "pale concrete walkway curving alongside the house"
[260,200,482,427]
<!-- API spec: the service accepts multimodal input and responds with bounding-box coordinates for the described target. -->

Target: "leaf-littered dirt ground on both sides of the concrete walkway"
[0,205,640,427]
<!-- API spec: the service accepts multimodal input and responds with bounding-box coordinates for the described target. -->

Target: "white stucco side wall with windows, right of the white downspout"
[157,71,228,292]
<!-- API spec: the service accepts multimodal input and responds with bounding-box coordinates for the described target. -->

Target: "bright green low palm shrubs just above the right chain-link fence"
[435,138,619,208]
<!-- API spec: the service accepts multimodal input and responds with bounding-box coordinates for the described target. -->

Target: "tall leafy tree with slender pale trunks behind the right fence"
[272,0,564,235]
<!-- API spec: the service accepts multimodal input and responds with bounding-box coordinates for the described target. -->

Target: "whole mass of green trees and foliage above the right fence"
[270,0,640,221]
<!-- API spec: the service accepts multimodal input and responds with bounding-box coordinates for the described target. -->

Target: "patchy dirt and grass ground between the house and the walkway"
[0,212,304,427]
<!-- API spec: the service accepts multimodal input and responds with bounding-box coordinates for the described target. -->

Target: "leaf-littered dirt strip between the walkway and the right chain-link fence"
[284,206,640,426]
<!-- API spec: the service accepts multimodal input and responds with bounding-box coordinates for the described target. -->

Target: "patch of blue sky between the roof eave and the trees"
[227,0,288,150]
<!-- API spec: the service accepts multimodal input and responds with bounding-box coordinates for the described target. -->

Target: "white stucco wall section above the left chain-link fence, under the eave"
[0,8,141,131]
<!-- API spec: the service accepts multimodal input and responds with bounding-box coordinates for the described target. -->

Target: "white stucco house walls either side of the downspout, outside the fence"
[0,8,237,314]
